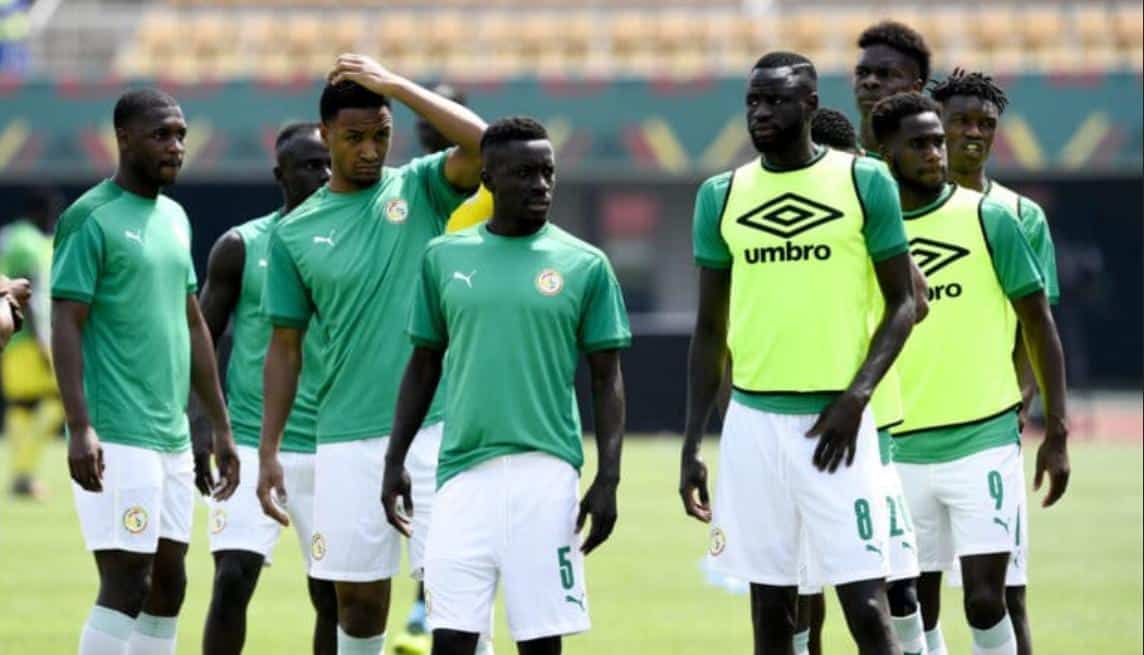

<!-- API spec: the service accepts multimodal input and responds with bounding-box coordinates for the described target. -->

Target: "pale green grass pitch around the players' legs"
[0,438,1144,655]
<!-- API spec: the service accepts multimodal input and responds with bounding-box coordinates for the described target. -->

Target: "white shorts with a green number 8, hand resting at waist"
[709,400,889,586]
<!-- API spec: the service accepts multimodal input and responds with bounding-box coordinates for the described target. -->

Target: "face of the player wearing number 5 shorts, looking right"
[482,139,556,223]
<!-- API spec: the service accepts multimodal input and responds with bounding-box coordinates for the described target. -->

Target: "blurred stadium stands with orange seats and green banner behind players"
[0,0,1144,431]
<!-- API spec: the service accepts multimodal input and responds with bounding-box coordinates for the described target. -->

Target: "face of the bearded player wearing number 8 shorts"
[746,66,818,152]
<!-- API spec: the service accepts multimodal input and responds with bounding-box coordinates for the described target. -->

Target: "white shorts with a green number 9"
[898,444,1027,572]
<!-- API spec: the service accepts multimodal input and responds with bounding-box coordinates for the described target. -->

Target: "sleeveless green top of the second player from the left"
[227,211,321,453]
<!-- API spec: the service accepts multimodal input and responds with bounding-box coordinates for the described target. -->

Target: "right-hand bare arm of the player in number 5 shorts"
[575,350,626,554]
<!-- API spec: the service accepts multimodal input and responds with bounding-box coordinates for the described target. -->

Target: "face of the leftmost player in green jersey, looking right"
[116,105,186,186]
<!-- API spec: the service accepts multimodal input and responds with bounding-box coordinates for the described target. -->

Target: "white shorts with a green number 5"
[425,453,591,641]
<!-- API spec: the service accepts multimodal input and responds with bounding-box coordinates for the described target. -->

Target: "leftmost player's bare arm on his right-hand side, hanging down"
[186,294,239,501]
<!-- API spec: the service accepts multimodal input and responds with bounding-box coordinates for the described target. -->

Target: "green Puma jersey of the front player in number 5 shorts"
[408,224,631,486]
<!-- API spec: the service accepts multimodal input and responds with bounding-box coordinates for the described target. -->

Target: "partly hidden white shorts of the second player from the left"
[207,446,315,569]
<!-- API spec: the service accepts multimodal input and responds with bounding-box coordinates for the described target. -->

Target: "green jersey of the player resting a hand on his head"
[262,152,469,444]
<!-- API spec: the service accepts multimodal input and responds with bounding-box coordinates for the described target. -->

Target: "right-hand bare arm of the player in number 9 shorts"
[1012,291,1070,508]
